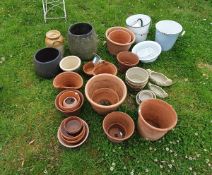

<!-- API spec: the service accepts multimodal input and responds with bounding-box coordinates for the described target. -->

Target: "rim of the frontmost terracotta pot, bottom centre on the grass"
[102,111,135,141]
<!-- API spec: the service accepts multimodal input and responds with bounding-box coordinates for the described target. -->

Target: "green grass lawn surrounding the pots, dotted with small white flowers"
[0,0,212,175]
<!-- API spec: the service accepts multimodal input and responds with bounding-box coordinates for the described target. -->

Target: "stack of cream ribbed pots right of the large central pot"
[125,67,149,91]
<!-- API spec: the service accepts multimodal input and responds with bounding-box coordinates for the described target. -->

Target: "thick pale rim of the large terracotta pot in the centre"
[85,73,127,109]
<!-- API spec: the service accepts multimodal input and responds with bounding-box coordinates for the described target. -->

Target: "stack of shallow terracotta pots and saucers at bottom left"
[57,116,89,148]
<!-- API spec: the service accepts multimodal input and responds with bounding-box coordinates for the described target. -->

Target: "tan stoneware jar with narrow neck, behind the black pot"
[45,30,64,57]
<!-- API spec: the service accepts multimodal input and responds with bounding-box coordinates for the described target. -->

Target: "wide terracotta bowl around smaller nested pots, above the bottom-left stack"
[55,90,84,116]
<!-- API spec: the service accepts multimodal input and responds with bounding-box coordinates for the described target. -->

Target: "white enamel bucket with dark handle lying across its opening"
[126,14,151,43]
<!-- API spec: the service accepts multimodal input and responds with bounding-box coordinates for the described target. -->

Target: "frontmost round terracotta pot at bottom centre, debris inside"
[102,111,135,143]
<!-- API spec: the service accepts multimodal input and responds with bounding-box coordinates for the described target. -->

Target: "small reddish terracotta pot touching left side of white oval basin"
[117,51,139,72]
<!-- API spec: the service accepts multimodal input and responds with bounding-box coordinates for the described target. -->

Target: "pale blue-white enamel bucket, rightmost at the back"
[155,20,185,51]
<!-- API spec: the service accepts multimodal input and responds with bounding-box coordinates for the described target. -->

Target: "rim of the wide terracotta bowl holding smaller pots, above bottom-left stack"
[54,89,84,113]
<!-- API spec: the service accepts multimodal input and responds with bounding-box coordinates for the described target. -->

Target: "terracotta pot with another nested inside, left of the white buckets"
[105,27,135,55]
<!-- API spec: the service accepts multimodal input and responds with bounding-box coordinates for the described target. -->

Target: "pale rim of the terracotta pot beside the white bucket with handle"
[105,26,135,46]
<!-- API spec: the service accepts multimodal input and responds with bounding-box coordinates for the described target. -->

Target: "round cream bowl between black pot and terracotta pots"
[60,56,81,72]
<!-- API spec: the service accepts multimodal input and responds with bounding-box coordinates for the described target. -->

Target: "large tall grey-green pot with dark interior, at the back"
[68,23,98,60]
